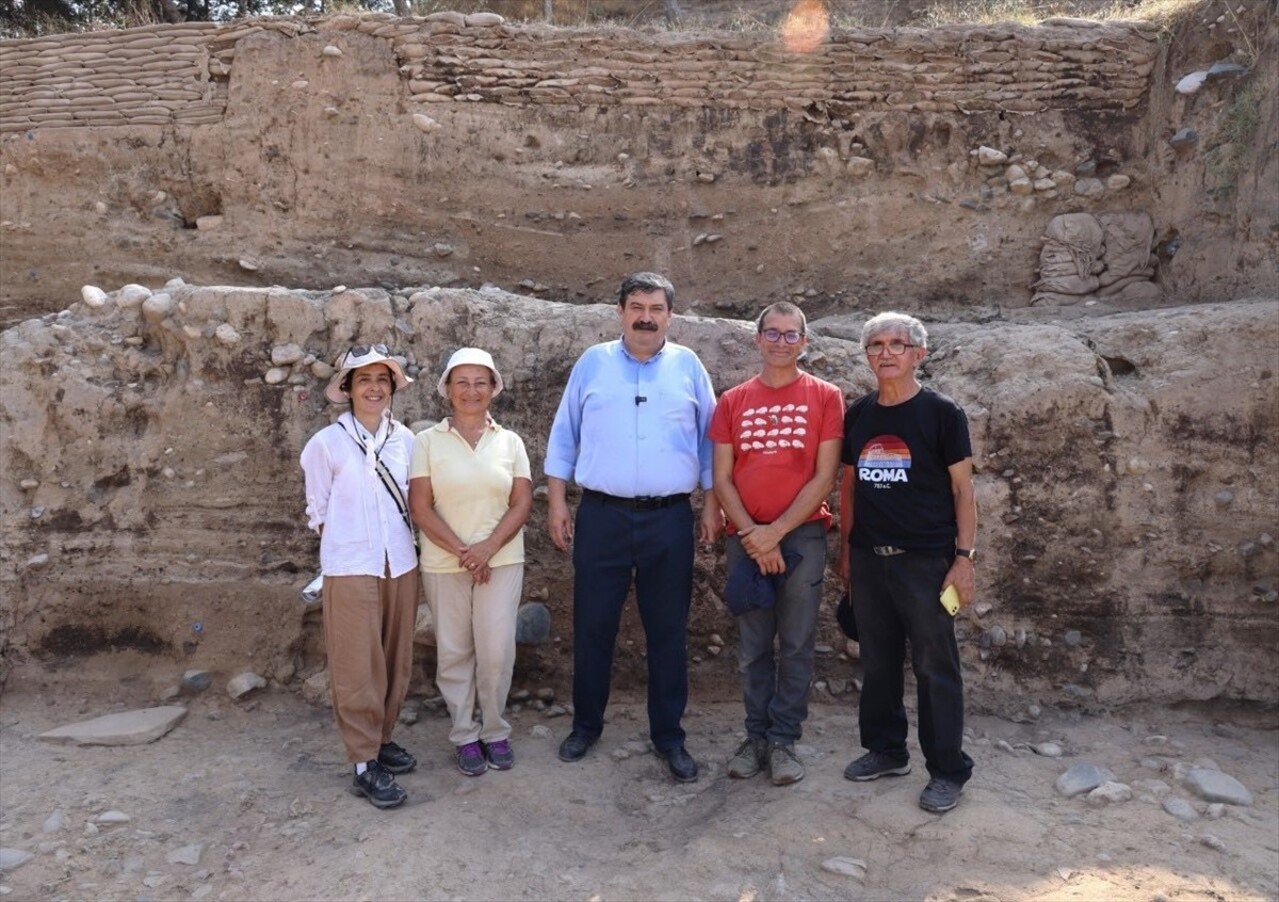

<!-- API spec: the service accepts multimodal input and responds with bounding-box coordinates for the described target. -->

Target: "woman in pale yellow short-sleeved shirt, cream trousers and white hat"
[409,348,533,777]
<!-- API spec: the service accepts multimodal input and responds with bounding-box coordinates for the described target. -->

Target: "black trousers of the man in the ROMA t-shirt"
[852,548,972,784]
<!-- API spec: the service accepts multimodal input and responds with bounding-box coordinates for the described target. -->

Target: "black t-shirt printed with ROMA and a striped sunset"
[843,389,972,554]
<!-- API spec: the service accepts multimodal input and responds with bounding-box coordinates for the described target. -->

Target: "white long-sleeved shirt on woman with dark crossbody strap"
[302,412,417,577]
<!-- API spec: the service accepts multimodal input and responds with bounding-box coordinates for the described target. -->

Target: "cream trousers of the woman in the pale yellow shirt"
[422,564,524,746]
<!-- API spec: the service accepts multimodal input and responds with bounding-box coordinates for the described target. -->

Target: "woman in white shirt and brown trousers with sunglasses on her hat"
[302,344,420,809]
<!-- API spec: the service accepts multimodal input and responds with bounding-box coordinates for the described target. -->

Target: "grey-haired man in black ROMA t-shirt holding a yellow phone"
[839,313,977,814]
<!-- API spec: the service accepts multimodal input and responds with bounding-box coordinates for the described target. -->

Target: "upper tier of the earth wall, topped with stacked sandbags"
[0,3,1279,322]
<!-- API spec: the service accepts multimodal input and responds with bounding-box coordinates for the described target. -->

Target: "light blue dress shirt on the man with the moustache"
[544,339,715,498]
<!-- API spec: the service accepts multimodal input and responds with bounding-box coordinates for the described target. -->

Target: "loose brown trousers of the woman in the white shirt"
[324,567,418,764]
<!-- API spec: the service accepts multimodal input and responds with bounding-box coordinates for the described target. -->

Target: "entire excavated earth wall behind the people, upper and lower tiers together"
[0,3,1279,706]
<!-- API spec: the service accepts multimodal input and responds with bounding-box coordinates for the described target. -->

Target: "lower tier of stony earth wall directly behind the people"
[0,283,1279,709]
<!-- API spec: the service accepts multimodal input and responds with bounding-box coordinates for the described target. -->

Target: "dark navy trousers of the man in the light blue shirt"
[573,495,693,751]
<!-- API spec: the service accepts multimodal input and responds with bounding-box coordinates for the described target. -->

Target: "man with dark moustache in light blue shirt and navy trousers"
[545,273,724,783]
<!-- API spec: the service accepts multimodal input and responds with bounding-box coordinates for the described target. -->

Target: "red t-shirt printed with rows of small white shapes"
[710,372,844,534]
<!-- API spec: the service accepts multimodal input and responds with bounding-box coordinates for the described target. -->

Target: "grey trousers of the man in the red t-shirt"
[725,521,826,746]
